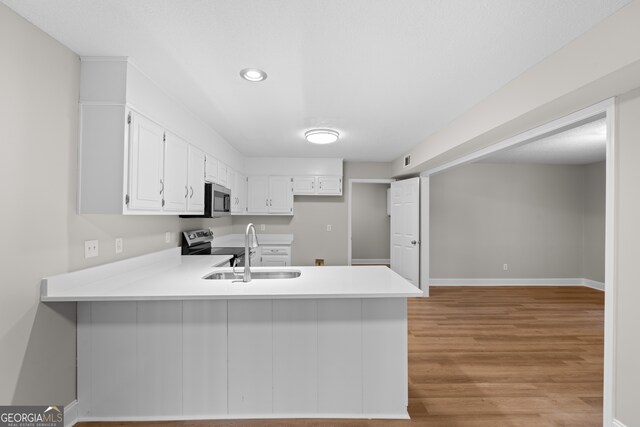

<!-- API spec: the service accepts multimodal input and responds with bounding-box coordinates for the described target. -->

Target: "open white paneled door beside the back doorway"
[391,178,420,287]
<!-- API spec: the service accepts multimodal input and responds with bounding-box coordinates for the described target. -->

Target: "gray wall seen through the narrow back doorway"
[351,183,391,260]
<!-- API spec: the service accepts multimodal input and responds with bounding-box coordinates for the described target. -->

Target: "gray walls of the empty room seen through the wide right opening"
[430,162,605,281]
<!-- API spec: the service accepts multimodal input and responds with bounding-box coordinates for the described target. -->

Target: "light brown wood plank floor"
[79,287,604,427]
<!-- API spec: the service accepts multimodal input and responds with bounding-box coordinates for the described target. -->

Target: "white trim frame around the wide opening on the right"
[420,98,617,426]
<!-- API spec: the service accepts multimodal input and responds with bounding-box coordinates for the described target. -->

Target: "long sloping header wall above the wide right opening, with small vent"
[392,0,640,177]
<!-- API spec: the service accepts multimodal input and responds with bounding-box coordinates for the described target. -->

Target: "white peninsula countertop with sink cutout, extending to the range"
[41,248,422,301]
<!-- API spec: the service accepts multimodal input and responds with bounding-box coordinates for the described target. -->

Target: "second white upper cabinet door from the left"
[163,133,189,212]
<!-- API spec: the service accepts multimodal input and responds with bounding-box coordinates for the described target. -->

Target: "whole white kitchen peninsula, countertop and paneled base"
[41,248,422,421]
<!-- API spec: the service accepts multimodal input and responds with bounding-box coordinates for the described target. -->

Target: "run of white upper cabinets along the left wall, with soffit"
[78,57,243,215]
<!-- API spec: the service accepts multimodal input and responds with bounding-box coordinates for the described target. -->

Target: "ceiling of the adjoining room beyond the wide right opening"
[482,119,607,165]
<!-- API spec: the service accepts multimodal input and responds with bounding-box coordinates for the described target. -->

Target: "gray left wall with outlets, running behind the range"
[0,4,231,405]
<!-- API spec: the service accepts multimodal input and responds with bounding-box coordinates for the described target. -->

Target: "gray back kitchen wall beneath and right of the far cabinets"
[233,162,391,265]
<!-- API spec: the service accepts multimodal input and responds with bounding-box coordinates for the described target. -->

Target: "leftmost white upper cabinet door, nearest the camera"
[129,112,164,211]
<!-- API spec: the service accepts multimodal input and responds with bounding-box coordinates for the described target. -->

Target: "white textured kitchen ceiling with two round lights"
[1,0,629,161]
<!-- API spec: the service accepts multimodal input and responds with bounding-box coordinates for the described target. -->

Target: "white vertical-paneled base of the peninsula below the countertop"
[77,298,408,421]
